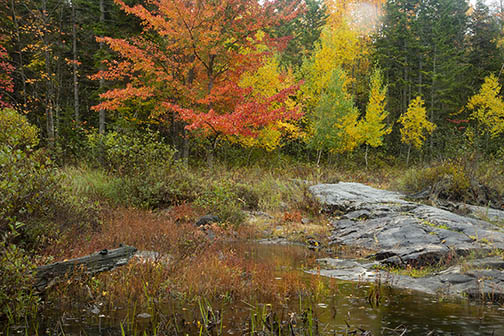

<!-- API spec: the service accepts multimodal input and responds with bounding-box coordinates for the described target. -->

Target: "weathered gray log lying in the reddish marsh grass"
[35,246,137,291]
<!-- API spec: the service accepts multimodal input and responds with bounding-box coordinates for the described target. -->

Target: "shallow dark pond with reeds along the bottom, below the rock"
[2,243,504,335]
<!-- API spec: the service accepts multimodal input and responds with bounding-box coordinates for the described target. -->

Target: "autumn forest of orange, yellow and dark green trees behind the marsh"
[0,0,504,163]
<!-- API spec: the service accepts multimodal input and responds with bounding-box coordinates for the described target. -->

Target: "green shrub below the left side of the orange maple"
[81,131,214,209]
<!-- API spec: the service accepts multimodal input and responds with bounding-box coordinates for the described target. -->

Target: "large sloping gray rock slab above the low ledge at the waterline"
[310,182,504,266]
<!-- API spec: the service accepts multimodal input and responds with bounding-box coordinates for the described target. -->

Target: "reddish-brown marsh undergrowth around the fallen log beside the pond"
[38,204,329,336]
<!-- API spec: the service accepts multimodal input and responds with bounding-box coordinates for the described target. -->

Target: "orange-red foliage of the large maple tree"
[93,0,303,136]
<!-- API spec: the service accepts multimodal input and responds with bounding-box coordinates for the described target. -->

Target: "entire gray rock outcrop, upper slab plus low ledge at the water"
[310,182,504,302]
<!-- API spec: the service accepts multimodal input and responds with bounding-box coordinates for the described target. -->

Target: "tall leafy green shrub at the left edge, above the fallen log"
[0,110,97,248]
